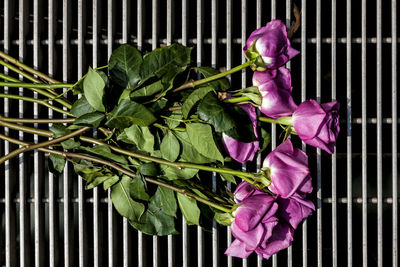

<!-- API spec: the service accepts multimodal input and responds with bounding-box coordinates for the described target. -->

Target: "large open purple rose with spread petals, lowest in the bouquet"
[225,181,315,259]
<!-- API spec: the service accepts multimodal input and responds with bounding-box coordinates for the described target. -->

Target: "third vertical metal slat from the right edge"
[361,0,368,267]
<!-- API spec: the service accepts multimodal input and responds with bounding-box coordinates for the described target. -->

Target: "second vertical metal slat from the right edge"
[376,0,383,267]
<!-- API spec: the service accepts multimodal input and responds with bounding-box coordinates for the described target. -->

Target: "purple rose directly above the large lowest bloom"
[263,139,312,198]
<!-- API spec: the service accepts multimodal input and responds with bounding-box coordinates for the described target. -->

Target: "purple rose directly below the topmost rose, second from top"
[253,67,297,119]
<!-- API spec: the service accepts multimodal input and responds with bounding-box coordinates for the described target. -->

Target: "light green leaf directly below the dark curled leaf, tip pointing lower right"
[186,123,224,162]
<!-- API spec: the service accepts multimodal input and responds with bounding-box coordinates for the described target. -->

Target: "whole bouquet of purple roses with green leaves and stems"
[0,20,339,258]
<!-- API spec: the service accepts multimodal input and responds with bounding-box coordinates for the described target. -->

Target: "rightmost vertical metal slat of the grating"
[392,0,399,267]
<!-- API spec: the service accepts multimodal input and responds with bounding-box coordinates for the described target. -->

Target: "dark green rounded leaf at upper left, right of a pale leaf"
[108,44,143,89]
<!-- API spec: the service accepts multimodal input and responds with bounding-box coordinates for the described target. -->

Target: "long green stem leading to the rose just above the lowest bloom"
[0,121,253,181]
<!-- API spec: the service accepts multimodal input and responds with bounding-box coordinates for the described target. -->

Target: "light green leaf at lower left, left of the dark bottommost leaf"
[111,175,145,221]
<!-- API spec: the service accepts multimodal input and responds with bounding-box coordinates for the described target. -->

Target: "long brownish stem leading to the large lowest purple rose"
[0,134,231,215]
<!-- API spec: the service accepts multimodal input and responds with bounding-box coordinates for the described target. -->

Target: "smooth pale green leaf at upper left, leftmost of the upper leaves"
[83,67,106,112]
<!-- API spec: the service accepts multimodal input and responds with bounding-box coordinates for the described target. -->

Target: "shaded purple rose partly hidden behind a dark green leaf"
[222,104,260,163]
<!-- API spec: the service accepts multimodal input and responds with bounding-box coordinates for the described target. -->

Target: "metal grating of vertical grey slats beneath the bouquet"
[0,0,399,267]
